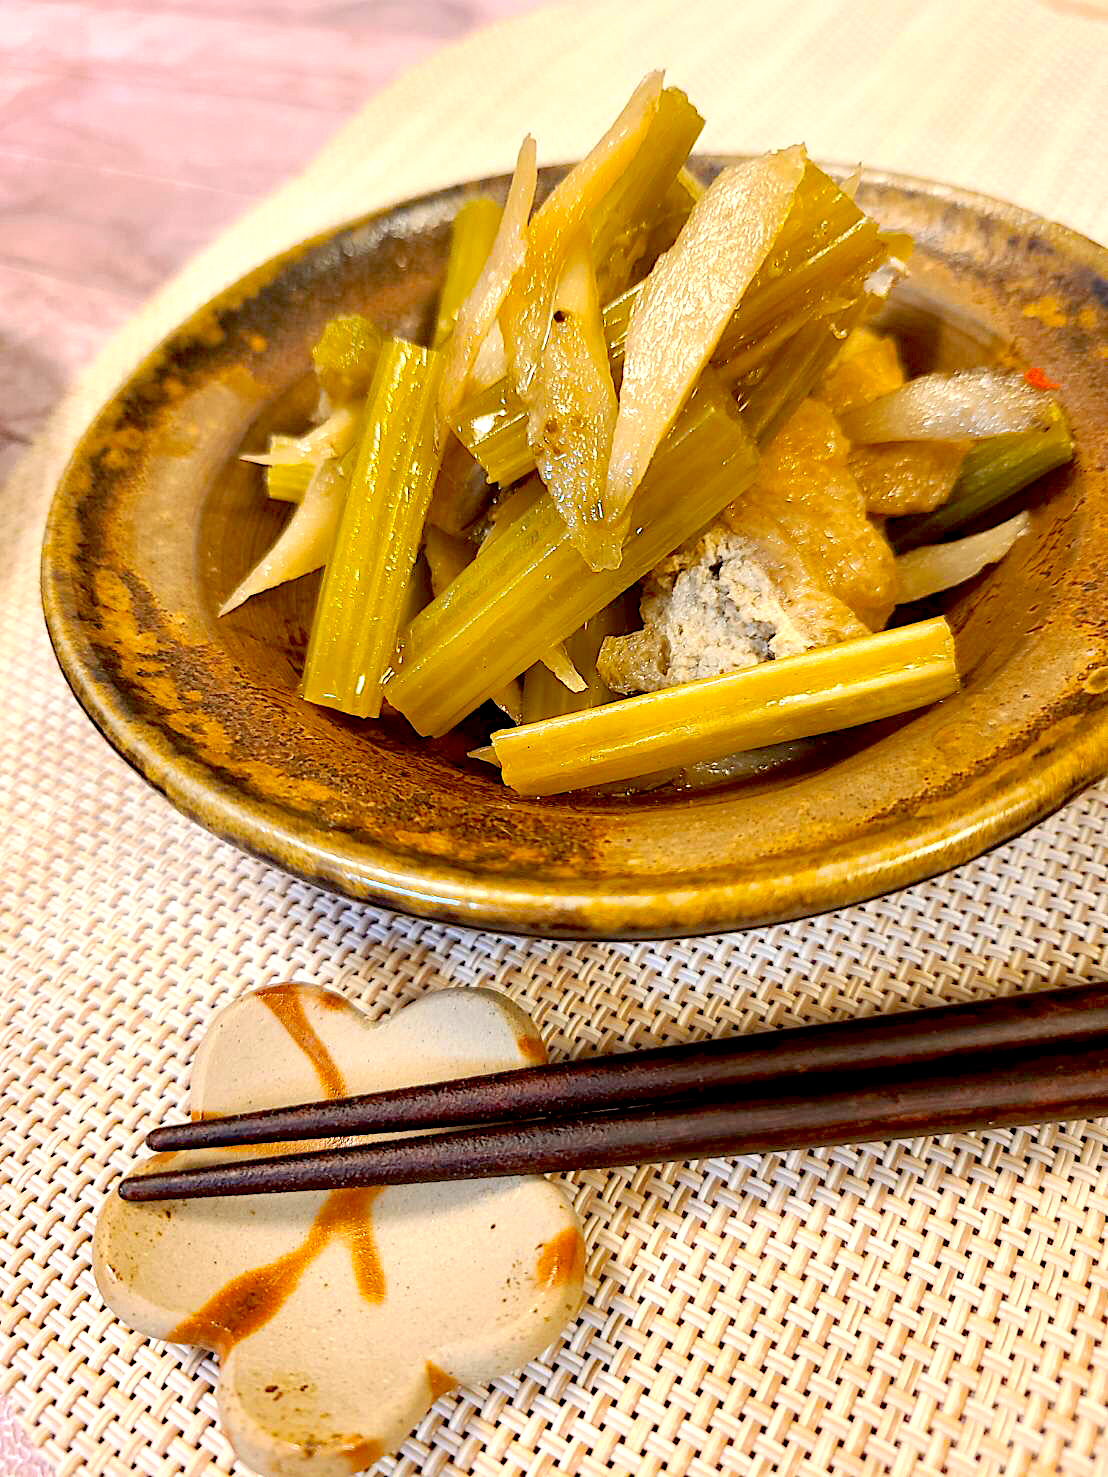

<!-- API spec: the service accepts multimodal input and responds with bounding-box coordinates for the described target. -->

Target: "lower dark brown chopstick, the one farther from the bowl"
[120,1046,1108,1201]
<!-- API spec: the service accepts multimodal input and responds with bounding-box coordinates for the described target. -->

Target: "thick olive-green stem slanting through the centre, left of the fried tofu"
[387,375,756,734]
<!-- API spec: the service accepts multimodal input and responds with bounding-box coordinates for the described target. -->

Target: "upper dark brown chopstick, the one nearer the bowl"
[146,982,1108,1149]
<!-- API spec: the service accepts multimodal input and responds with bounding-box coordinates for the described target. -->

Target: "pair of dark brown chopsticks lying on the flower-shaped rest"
[120,982,1108,1201]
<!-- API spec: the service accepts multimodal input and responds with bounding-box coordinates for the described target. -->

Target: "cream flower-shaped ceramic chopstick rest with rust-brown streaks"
[95,985,584,1477]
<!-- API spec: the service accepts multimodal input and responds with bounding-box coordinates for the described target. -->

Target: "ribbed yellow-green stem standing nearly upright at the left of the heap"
[301,340,442,718]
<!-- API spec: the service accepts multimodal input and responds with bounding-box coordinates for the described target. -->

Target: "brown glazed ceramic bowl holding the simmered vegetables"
[43,160,1108,938]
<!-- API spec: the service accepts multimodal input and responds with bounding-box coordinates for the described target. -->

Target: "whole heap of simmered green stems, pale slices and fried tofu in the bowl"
[223,72,1073,795]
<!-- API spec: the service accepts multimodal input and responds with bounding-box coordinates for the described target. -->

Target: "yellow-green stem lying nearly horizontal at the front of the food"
[492,620,957,795]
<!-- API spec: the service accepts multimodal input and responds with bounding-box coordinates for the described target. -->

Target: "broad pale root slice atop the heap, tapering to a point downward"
[604,145,807,523]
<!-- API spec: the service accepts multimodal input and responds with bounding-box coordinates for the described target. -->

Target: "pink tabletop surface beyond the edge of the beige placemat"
[0,0,538,1477]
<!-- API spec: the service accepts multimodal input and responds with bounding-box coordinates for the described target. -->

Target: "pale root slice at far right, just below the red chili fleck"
[842,369,1053,442]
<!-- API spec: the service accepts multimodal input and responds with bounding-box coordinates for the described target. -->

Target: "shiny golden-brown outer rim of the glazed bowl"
[41,154,1108,941]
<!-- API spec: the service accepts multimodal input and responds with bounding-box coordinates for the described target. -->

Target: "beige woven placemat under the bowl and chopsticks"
[0,0,1108,1477]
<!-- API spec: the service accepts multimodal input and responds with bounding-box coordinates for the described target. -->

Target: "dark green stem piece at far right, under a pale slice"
[888,403,1074,554]
